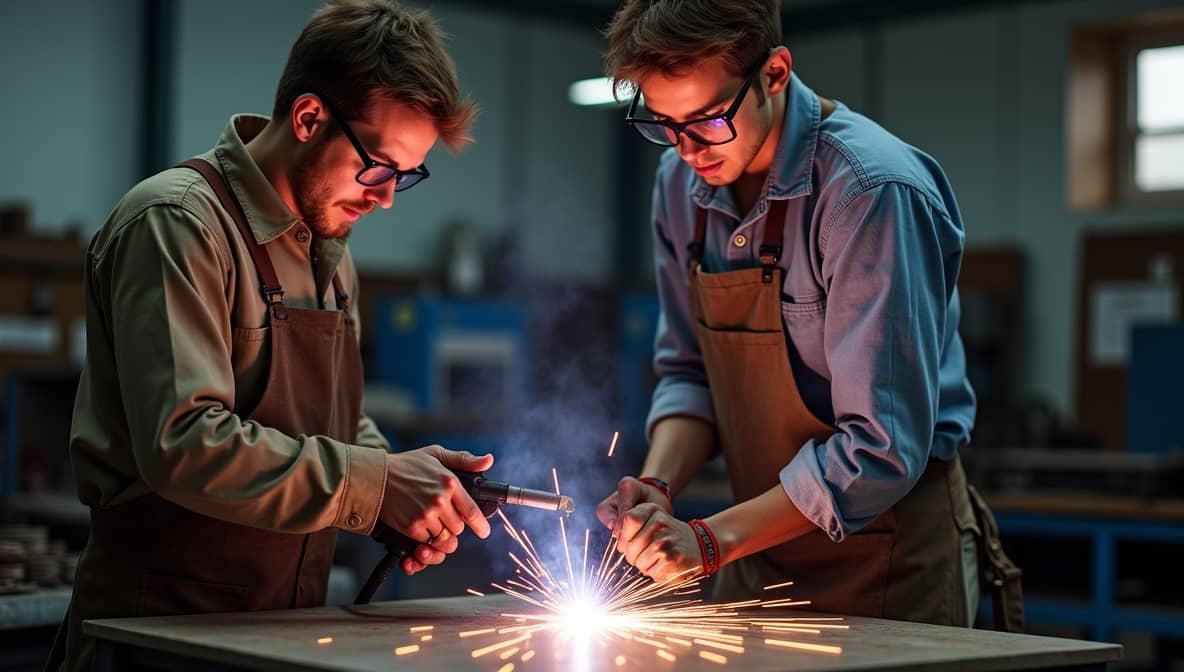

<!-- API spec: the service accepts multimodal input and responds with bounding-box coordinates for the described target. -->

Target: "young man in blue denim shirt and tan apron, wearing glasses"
[597,0,1022,626]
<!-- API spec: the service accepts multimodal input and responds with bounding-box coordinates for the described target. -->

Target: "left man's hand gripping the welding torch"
[379,446,494,576]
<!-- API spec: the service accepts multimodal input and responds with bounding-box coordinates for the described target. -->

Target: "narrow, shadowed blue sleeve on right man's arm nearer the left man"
[645,168,715,439]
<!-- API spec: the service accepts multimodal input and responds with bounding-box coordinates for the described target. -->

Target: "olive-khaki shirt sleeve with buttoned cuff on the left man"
[94,205,386,532]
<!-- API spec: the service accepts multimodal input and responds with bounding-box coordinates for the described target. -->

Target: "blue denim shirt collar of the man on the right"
[691,75,822,211]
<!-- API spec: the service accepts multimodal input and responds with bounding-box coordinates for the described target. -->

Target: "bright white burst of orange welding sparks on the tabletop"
[395,456,849,670]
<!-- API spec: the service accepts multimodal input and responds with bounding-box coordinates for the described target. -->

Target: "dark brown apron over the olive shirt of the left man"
[46,159,362,671]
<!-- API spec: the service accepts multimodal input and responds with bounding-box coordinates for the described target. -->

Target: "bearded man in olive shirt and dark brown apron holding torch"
[47,0,493,670]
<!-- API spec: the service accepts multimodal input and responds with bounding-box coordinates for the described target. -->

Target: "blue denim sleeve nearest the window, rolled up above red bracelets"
[780,182,961,541]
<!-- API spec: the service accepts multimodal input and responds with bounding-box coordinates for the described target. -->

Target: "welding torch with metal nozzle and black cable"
[354,471,575,605]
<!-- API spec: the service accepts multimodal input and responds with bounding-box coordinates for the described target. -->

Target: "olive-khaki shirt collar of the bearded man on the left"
[213,115,300,244]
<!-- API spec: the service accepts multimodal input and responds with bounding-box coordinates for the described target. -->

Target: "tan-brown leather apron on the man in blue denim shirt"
[690,199,978,626]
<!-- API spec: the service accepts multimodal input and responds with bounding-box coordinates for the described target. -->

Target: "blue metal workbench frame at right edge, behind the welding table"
[984,511,1184,641]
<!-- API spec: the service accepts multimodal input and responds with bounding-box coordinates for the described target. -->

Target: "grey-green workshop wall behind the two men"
[0,0,1184,414]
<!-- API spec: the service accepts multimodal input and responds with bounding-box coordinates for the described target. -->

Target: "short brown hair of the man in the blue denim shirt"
[604,0,781,90]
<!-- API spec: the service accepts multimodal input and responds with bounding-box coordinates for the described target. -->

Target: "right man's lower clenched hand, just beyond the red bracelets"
[617,503,703,581]
